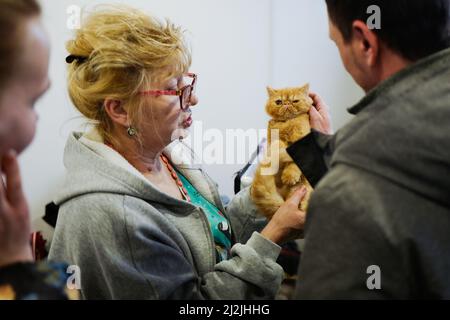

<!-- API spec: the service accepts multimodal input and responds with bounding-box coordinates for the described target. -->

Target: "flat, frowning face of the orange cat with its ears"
[266,85,313,121]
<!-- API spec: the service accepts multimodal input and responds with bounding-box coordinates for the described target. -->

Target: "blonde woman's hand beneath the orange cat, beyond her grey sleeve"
[261,187,307,244]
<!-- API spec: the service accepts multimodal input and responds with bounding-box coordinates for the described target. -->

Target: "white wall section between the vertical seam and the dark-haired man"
[271,0,363,129]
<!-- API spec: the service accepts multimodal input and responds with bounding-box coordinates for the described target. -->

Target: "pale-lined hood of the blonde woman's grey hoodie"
[54,130,222,212]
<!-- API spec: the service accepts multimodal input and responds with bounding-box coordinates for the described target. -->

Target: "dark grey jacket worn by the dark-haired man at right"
[289,49,450,299]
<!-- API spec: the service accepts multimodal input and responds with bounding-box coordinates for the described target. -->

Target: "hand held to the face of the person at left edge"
[0,151,33,267]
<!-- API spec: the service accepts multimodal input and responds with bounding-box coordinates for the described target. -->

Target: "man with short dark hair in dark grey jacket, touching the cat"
[288,0,450,299]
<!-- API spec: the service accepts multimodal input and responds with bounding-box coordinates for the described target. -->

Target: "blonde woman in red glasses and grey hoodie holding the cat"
[50,8,304,299]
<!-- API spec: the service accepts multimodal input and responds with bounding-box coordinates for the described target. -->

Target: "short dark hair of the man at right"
[326,0,450,61]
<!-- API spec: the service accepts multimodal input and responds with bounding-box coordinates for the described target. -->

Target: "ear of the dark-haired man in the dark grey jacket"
[352,20,380,67]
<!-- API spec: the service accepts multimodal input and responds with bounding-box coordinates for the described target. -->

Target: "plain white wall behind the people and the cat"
[20,0,361,233]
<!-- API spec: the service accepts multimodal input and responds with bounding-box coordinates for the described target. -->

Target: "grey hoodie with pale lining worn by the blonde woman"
[49,132,283,299]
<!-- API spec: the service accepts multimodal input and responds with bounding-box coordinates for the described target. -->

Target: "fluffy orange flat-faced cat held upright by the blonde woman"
[251,85,313,219]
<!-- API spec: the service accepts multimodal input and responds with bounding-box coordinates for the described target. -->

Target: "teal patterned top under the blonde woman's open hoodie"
[177,171,233,263]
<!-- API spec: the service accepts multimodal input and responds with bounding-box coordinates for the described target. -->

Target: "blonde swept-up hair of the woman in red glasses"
[67,7,191,142]
